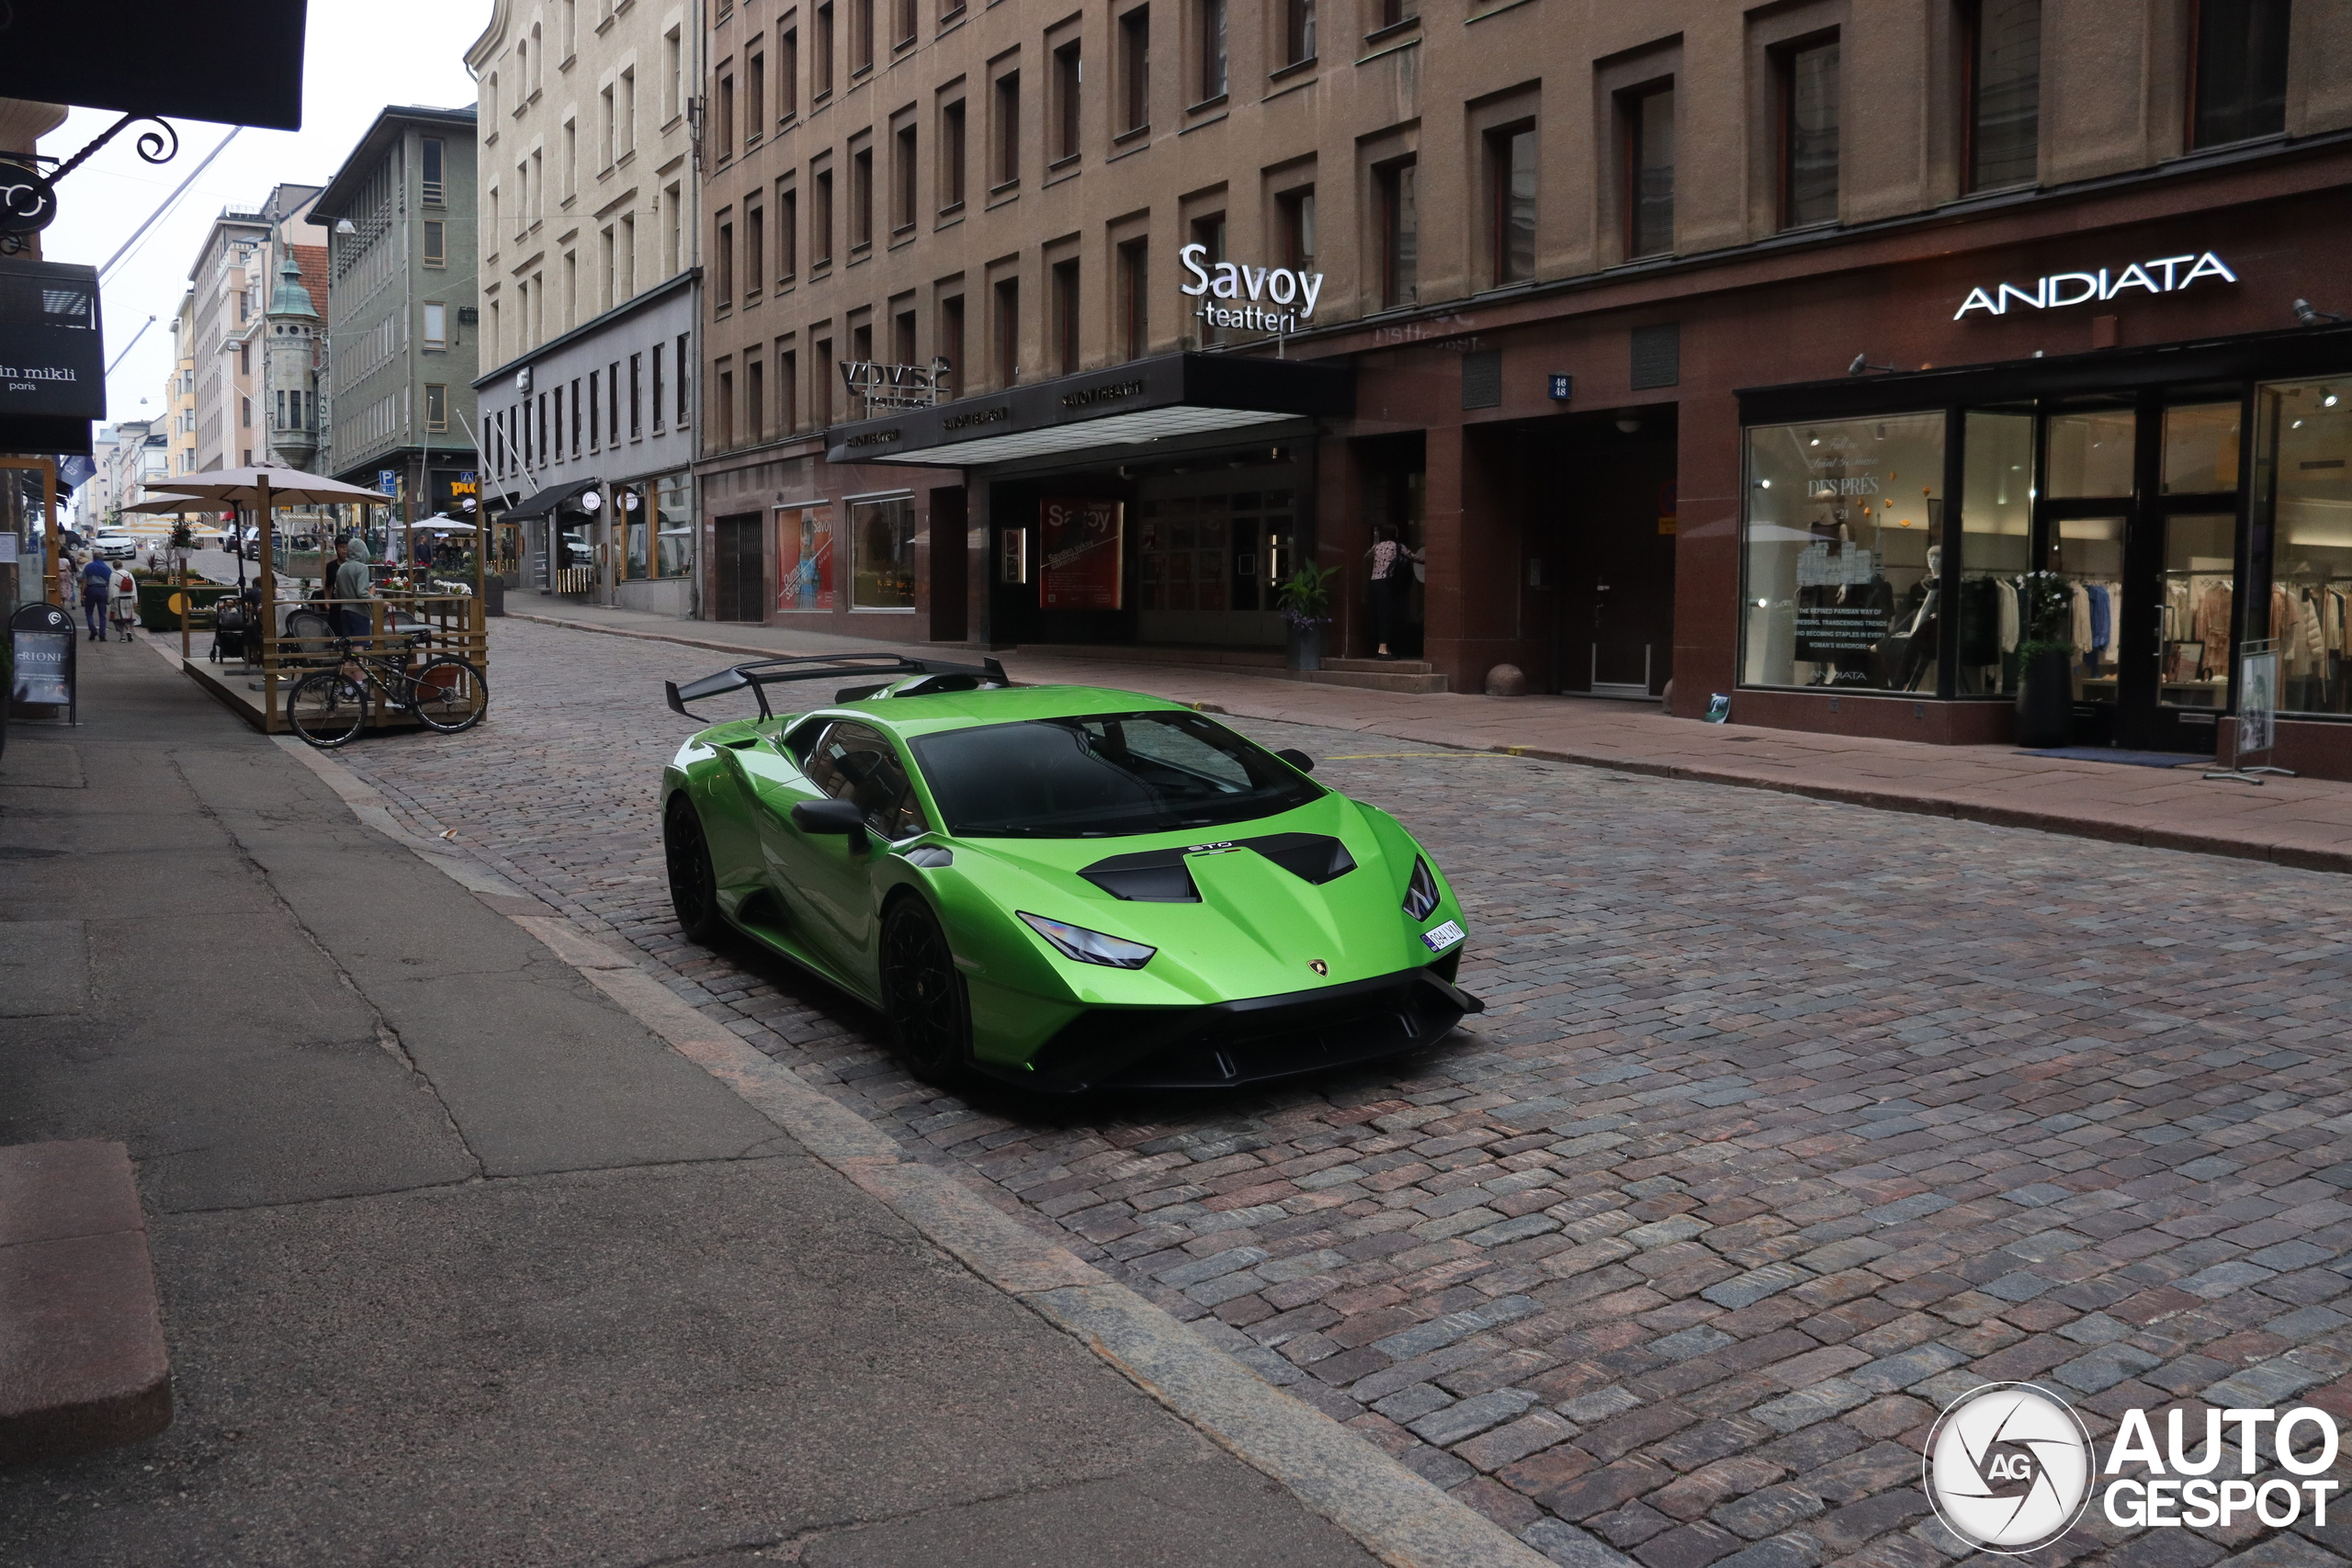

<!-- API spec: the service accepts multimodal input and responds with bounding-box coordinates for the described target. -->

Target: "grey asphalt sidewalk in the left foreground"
[0,644,1448,1568]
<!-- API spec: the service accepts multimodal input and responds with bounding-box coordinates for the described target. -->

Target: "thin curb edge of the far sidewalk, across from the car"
[508,614,2352,874]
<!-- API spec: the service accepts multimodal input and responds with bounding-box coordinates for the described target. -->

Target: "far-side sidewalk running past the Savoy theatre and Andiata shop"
[508,594,2352,872]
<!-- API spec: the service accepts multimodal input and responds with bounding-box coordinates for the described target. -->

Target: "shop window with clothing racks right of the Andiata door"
[2246,376,2352,712]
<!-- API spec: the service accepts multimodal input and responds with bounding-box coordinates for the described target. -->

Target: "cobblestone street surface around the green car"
[341,621,2352,1568]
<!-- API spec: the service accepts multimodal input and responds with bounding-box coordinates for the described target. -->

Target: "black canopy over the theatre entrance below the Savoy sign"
[826,353,1355,468]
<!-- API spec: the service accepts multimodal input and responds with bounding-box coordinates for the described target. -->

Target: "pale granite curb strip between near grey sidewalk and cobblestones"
[273,733,1552,1568]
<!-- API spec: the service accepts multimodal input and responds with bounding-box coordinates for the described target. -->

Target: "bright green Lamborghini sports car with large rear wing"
[661,653,1484,1093]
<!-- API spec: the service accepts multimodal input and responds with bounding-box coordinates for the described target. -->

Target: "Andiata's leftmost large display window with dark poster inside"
[1740,412,1945,694]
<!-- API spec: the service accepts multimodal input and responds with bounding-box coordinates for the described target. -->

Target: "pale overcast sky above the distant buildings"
[40,0,489,432]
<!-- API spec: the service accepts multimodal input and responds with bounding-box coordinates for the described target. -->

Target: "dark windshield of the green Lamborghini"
[915,712,1322,840]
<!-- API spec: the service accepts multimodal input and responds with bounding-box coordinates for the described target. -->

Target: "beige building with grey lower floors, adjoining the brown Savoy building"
[466,0,703,616]
